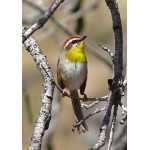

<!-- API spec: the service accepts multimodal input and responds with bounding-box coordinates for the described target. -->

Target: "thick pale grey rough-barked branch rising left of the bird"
[22,28,55,150]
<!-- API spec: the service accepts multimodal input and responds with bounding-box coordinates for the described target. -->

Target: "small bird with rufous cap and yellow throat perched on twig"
[57,35,88,134]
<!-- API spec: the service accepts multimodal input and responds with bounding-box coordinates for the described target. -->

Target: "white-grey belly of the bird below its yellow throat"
[61,61,87,91]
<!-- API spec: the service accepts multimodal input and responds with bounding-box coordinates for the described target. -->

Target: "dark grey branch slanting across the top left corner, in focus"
[22,0,64,43]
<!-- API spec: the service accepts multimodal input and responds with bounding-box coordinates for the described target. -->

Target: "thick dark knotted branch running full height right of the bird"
[90,0,123,150]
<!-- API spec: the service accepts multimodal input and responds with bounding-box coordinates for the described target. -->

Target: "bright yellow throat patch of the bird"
[65,42,86,63]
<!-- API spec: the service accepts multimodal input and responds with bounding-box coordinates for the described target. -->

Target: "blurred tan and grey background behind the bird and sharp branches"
[22,0,127,150]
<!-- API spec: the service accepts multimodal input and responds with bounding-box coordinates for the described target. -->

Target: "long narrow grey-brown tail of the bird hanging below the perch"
[70,90,88,133]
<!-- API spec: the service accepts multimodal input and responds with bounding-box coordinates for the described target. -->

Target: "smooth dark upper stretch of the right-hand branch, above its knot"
[105,0,123,83]
